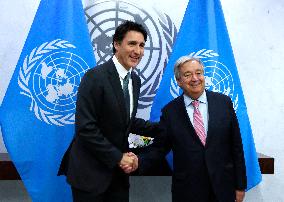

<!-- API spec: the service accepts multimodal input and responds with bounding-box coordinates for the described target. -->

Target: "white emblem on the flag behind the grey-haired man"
[170,49,238,111]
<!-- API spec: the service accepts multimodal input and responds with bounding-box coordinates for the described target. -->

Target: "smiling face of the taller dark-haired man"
[114,31,145,70]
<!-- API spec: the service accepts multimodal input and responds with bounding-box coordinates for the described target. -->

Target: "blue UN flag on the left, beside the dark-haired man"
[0,0,95,202]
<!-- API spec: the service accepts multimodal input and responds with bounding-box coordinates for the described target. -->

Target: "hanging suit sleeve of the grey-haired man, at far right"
[229,99,247,190]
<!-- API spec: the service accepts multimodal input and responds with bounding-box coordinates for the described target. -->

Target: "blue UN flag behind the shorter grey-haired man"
[151,0,261,189]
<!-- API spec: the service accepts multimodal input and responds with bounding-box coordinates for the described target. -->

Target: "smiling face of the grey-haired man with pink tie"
[177,60,205,100]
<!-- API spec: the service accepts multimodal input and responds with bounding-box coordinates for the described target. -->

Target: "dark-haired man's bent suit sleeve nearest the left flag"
[76,71,123,168]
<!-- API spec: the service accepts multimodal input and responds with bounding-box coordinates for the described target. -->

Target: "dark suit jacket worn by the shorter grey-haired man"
[139,91,246,202]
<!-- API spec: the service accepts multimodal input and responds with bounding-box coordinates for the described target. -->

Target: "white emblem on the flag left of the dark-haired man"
[18,39,88,126]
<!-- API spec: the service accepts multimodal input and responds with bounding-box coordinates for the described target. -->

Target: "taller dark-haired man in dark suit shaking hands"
[58,21,157,202]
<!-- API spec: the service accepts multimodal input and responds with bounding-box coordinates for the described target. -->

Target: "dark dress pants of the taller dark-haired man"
[71,169,129,202]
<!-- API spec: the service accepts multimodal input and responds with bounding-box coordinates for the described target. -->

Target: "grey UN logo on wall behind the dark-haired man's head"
[85,0,177,109]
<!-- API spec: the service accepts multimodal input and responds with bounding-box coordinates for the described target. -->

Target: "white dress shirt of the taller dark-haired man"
[112,55,133,118]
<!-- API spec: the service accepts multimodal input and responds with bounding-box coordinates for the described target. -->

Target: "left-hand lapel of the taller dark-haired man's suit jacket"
[107,60,126,122]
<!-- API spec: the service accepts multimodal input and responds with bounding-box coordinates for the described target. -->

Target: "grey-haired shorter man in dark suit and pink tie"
[134,56,247,202]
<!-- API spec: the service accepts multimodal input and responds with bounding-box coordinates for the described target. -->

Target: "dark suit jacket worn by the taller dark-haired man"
[58,60,157,194]
